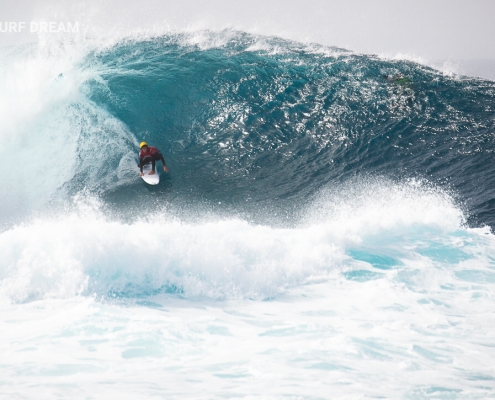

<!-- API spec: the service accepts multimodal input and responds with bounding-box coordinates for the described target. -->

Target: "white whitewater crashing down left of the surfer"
[0,43,135,222]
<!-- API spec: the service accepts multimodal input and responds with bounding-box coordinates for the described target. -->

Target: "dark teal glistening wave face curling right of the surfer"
[78,33,495,225]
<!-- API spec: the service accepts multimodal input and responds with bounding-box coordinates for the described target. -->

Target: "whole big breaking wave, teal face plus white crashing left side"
[0,31,495,226]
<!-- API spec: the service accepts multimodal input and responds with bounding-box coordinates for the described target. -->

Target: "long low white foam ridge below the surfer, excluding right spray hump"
[0,209,342,302]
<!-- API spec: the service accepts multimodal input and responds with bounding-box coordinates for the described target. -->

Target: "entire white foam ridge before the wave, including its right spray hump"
[0,181,462,302]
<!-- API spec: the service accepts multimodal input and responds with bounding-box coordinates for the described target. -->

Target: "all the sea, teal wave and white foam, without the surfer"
[0,30,495,399]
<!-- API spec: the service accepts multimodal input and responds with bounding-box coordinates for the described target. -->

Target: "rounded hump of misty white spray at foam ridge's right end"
[305,178,465,236]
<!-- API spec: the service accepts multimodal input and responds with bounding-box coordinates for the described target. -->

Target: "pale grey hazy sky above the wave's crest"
[0,0,495,77]
